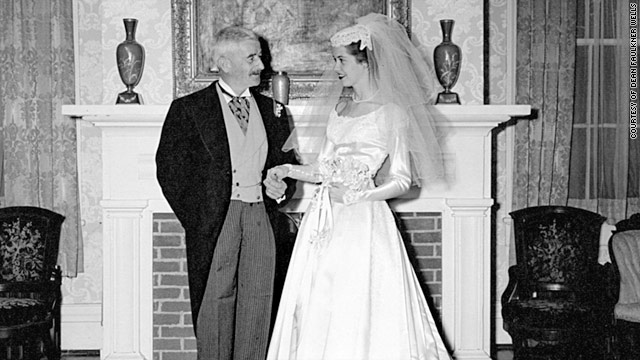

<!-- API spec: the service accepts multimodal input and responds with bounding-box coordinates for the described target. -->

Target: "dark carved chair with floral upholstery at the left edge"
[0,206,64,360]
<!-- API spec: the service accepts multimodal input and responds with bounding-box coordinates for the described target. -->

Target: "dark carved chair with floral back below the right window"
[502,206,615,360]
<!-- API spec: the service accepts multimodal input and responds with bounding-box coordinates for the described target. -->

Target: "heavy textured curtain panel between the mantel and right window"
[513,0,576,210]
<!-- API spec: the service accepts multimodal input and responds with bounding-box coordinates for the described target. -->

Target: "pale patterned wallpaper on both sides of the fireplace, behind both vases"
[70,0,507,340]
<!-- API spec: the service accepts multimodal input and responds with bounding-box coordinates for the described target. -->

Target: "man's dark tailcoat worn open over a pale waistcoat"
[156,82,297,330]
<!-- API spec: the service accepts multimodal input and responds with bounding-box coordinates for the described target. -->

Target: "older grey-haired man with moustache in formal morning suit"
[156,27,295,360]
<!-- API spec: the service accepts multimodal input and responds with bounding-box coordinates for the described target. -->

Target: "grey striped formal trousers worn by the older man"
[197,200,275,360]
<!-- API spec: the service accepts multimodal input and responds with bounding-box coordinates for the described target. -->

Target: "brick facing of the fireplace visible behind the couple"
[153,213,442,360]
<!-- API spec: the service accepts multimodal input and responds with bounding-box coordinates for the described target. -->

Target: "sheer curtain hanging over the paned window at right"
[569,0,640,223]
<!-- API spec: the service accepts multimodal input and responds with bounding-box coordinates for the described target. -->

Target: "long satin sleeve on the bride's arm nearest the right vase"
[345,105,411,204]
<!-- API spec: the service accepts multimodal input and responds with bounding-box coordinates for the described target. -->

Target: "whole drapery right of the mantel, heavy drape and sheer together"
[510,0,640,263]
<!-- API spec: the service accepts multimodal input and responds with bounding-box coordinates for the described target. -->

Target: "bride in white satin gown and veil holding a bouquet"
[265,14,450,360]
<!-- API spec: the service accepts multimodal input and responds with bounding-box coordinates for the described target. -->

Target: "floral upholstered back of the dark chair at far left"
[0,206,64,282]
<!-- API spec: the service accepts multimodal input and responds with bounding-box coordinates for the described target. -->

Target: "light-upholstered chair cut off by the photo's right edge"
[609,213,640,360]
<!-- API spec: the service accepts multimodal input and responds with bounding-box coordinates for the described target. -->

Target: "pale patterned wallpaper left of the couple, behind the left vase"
[63,0,173,304]
